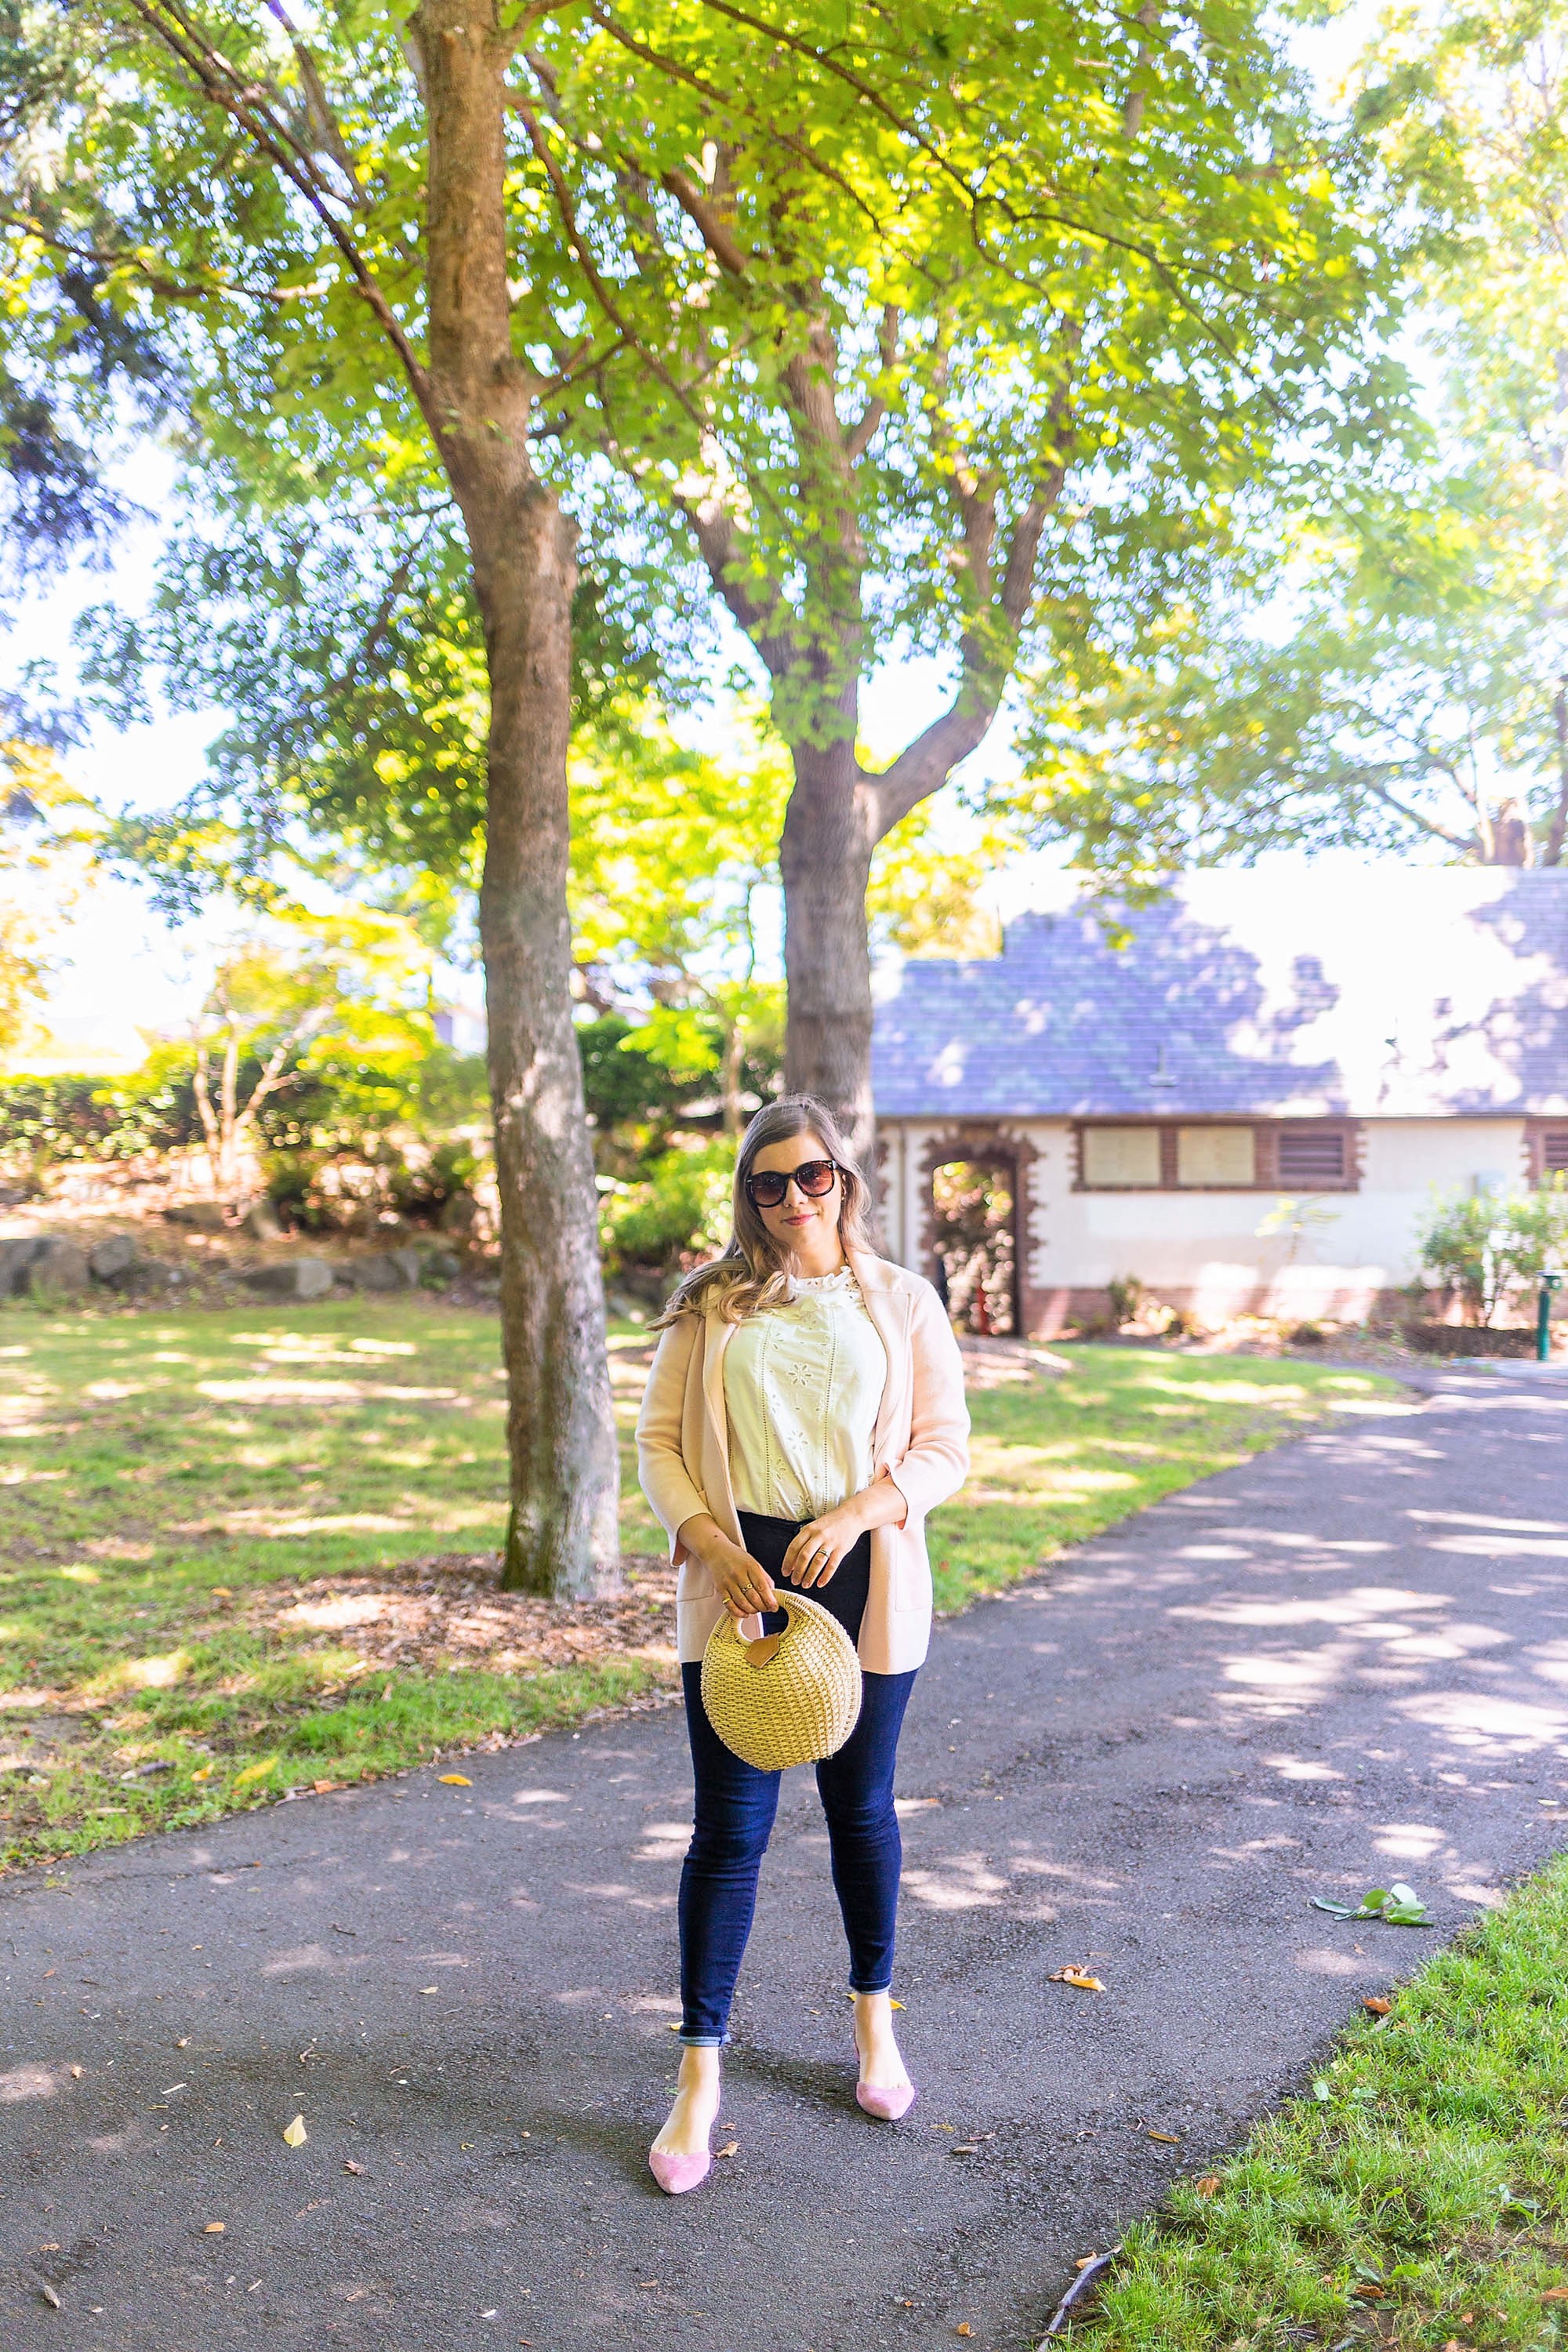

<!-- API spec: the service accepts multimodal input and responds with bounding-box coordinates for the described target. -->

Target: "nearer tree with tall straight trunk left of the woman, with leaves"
[27,0,982,1592]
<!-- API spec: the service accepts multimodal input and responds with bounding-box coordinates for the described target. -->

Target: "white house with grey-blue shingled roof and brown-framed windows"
[872,861,1568,1336]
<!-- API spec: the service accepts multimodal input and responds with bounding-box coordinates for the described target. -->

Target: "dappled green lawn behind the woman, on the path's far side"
[0,1298,1396,1865]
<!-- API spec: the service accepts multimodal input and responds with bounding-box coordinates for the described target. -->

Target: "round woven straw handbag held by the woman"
[703,1585,860,1771]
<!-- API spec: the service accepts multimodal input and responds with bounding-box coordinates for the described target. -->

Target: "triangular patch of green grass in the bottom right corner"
[1067,1860,1568,2352]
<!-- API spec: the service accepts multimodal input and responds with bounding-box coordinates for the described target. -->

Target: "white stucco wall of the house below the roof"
[884,1120,1526,1317]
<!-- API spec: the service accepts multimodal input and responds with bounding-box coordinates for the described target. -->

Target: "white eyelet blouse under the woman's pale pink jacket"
[724,1265,888,1519]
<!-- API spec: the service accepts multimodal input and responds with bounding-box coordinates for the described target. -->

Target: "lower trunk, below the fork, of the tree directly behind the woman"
[781,739,877,1171]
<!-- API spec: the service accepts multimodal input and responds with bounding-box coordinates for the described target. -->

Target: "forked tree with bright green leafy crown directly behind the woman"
[517,0,1399,1167]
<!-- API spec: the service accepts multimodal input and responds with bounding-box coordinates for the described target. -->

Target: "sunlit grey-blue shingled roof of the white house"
[872,861,1568,1120]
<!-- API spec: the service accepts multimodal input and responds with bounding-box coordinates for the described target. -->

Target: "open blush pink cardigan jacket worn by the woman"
[637,1251,968,1675]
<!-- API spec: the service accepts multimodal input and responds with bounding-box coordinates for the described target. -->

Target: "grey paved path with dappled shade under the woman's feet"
[0,1367,1568,2352]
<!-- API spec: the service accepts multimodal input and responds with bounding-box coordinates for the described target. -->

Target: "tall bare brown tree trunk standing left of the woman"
[412,0,621,1599]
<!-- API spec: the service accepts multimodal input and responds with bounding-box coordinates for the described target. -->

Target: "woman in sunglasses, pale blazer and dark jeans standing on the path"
[637,1096,968,2194]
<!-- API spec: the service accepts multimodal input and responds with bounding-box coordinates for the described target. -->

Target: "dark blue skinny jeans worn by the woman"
[680,1512,914,2049]
